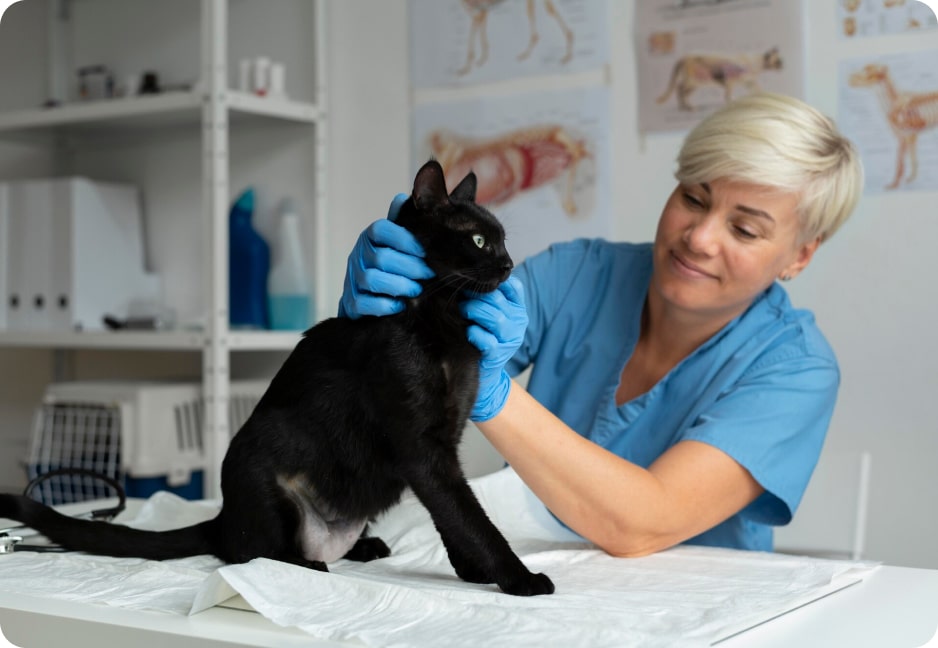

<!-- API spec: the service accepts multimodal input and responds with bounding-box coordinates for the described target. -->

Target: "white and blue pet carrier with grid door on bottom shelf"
[27,381,268,504]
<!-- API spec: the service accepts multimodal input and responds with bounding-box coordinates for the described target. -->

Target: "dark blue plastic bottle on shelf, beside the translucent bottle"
[228,188,270,329]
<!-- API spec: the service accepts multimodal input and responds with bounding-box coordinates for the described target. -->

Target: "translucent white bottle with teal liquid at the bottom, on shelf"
[267,200,312,331]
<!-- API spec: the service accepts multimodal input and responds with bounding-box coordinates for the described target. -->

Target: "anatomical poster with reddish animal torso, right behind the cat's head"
[413,86,611,263]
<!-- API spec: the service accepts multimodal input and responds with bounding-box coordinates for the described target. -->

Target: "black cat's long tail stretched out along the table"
[0,495,218,560]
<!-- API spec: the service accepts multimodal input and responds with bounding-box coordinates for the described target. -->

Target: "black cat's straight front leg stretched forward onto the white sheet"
[400,453,554,596]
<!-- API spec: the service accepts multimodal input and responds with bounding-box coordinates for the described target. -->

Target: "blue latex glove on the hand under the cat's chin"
[460,277,528,422]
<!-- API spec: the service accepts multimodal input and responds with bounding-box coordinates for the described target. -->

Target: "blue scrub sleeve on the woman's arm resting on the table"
[683,348,840,525]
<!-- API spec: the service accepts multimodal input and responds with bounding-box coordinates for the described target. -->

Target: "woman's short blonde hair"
[675,92,863,241]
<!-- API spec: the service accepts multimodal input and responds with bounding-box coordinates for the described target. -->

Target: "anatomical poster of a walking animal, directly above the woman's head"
[635,0,804,132]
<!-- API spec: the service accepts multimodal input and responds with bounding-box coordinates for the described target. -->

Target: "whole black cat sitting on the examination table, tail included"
[0,161,554,595]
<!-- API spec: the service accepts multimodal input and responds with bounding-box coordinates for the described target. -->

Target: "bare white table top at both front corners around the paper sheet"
[0,567,938,648]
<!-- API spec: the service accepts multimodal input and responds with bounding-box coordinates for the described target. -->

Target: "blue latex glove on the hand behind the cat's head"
[339,194,433,319]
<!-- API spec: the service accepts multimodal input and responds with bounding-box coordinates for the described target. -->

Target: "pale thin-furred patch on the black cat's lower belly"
[277,475,367,563]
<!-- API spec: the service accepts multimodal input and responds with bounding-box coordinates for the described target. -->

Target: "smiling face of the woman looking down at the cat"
[652,180,819,321]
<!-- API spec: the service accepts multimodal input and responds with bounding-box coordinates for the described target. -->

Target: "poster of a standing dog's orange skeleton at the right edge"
[837,50,938,193]
